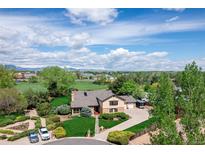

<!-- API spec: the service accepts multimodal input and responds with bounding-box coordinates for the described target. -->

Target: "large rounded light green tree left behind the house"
[40,66,75,96]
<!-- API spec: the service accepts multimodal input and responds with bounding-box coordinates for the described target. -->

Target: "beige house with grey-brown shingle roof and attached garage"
[71,90,136,115]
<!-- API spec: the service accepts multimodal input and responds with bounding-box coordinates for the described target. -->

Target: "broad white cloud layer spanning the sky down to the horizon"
[0,12,205,71]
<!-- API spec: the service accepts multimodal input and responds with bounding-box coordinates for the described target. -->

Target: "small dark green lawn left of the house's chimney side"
[51,96,71,108]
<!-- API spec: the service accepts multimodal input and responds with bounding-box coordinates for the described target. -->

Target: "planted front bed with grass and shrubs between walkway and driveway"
[99,112,129,129]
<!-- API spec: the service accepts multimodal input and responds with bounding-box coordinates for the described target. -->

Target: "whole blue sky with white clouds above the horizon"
[0,8,205,71]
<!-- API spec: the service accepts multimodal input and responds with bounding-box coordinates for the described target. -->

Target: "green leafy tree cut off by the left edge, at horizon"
[0,65,15,88]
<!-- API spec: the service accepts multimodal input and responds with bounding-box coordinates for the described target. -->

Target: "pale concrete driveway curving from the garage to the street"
[94,108,149,141]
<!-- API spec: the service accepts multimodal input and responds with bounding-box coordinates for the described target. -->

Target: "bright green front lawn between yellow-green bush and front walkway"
[63,117,95,137]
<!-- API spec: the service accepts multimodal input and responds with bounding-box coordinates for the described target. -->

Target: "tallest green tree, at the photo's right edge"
[180,62,205,144]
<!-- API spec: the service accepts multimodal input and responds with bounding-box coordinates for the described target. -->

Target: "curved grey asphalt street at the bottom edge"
[46,138,111,145]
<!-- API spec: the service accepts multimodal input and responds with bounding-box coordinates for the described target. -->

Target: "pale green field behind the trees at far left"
[15,82,47,93]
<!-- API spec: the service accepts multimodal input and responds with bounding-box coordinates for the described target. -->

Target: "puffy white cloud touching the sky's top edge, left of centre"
[65,8,118,25]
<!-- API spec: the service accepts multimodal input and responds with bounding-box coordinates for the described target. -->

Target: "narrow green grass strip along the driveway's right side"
[125,117,157,133]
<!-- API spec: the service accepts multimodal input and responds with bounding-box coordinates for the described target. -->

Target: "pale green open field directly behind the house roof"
[72,81,108,90]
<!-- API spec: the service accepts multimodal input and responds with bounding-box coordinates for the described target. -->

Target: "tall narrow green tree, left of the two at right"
[151,74,182,145]
